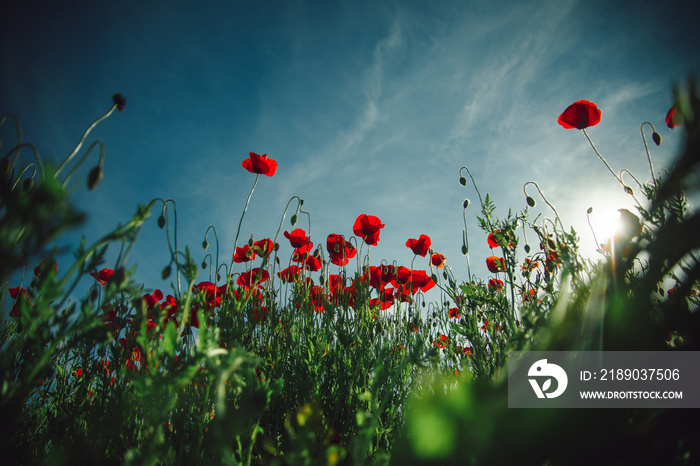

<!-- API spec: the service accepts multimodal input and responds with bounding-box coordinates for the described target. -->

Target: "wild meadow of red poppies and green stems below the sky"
[0,82,700,465]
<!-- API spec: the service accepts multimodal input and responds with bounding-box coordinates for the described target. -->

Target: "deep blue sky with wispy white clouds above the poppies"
[0,0,700,304]
